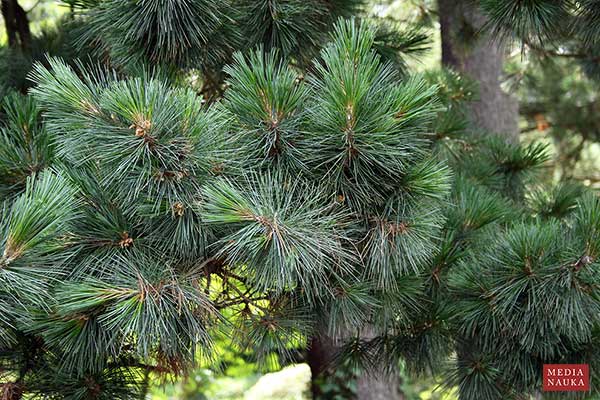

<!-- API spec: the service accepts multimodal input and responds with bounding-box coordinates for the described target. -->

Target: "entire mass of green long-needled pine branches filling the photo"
[0,0,600,400]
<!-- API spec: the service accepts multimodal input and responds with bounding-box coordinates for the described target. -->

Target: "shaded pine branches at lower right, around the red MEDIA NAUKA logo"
[432,67,598,399]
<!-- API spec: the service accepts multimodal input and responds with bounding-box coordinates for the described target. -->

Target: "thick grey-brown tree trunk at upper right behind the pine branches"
[438,0,519,143]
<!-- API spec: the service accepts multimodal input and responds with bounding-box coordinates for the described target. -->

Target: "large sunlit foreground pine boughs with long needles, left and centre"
[2,21,449,398]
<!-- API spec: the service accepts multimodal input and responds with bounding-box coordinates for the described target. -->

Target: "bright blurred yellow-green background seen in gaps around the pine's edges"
[0,0,600,400]
